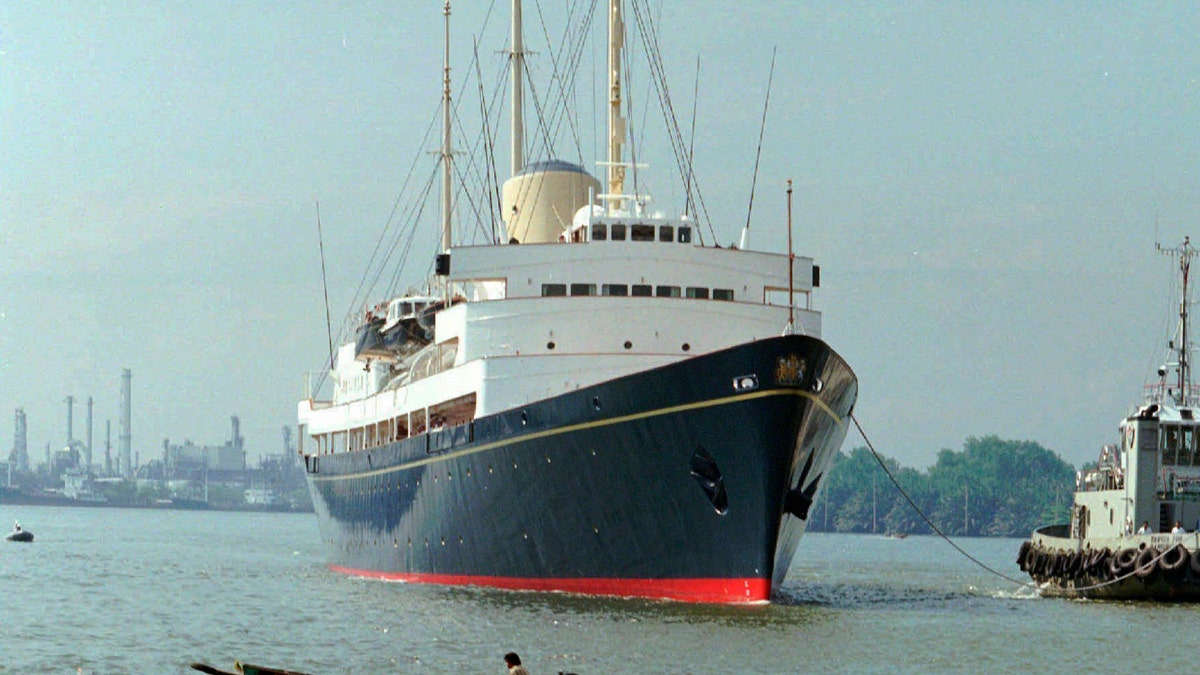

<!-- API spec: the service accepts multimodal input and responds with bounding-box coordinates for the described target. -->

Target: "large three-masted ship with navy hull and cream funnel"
[299,0,858,603]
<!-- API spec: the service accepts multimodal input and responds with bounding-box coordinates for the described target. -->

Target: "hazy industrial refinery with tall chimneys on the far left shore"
[0,369,312,510]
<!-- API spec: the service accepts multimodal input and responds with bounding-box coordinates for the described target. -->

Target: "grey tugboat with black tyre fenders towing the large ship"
[1016,238,1200,602]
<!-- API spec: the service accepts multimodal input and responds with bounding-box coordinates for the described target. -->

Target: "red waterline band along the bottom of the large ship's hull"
[329,565,770,604]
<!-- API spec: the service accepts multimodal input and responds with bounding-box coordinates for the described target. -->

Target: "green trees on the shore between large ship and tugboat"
[809,436,1075,537]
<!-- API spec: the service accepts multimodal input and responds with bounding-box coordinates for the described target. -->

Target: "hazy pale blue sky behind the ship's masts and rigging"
[0,0,1200,466]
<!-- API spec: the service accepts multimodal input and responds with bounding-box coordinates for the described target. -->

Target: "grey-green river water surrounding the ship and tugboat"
[0,504,1200,675]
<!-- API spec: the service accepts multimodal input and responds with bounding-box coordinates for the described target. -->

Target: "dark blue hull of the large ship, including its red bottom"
[307,336,858,602]
